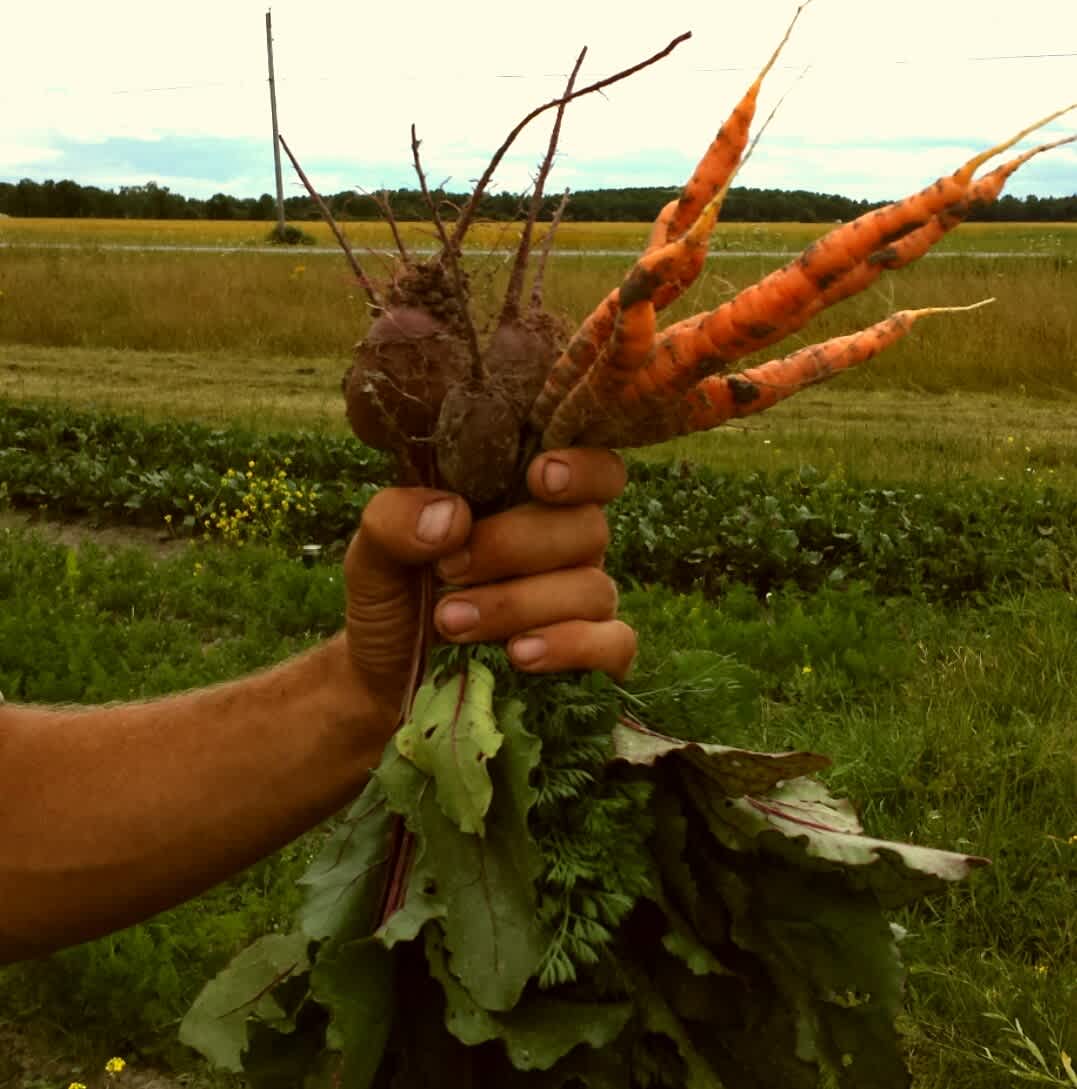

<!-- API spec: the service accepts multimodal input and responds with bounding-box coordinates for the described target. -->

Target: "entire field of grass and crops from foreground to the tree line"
[0,220,1077,1089]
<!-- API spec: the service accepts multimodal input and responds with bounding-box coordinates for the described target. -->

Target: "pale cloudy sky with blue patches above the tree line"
[0,0,1077,199]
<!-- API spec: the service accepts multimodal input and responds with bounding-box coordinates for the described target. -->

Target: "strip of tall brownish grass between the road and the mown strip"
[0,236,1077,395]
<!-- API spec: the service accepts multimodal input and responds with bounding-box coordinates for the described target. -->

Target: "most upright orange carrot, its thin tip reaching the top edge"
[530,9,811,431]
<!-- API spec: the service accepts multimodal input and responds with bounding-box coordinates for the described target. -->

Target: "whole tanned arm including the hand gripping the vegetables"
[0,451,635,963]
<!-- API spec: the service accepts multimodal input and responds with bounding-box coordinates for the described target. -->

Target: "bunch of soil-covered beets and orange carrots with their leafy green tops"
[181,5,1071,1089]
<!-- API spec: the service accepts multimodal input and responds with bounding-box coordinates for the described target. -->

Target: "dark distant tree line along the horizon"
[0,179,1077,223]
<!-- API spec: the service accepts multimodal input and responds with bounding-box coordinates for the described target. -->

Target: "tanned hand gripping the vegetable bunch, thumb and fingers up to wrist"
[344,449,636,717]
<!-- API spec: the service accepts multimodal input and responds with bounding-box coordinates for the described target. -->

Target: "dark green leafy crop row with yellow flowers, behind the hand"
[0,405,1077,600]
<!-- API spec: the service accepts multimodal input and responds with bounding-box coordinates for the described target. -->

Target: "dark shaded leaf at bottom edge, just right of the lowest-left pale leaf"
[310,938,393,1089]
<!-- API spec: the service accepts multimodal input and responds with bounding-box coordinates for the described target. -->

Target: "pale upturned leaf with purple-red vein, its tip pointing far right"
[685,771,987,907]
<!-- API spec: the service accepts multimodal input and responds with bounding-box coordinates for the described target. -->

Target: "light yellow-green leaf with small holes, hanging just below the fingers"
[396,660,502,835]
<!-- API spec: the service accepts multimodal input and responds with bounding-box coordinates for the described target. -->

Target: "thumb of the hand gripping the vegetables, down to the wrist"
[344,488,472,709]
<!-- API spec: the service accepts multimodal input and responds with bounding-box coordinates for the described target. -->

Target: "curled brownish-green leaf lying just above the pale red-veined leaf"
[613,722,830,798]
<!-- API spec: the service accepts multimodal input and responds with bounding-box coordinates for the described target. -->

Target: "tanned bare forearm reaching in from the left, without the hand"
[0,638,393,964]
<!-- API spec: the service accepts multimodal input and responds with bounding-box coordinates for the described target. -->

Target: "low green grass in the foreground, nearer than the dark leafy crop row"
[0,531,1077,1089]
